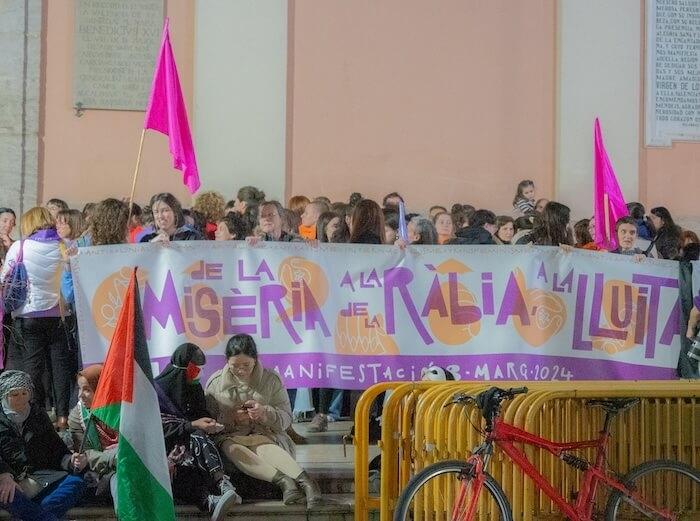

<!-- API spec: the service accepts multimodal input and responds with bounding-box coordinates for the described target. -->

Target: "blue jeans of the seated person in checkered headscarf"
[0,476,85,521]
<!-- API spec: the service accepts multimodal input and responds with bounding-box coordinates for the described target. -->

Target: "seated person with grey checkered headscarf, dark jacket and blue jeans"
[0,370,87,521]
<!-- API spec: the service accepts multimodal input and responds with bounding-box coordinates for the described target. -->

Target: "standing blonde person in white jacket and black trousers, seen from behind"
[0,207,78,429]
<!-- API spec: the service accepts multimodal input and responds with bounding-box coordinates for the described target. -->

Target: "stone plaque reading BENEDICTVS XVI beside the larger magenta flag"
[73,0,163,110]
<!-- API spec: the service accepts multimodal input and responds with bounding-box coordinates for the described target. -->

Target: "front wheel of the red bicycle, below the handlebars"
[394,460,513,521]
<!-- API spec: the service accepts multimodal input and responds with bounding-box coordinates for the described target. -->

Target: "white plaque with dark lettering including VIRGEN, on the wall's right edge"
[645,0,700,146]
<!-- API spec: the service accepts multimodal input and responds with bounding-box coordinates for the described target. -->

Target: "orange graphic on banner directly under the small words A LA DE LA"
[333,312,399,355]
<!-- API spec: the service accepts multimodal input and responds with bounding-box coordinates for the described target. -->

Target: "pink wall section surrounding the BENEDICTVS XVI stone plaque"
[39,0,194,206]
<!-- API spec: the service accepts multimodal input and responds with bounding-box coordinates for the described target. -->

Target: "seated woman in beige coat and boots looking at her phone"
[204,334,321,506]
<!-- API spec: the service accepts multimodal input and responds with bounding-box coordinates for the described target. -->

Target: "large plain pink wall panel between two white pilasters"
[287,0,556,211]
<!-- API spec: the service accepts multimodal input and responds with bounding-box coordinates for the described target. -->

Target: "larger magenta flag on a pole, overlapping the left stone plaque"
[143,18,201,194]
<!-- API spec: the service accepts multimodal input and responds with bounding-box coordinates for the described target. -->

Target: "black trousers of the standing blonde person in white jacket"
[7,317,78,417]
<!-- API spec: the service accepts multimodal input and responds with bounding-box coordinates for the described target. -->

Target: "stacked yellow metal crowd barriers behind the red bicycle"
[354,381,700,521]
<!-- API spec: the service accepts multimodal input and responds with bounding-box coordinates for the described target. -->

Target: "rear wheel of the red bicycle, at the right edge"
[605,460,700,521]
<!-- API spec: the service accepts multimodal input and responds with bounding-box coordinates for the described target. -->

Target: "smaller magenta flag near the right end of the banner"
[593,118,629,251]
